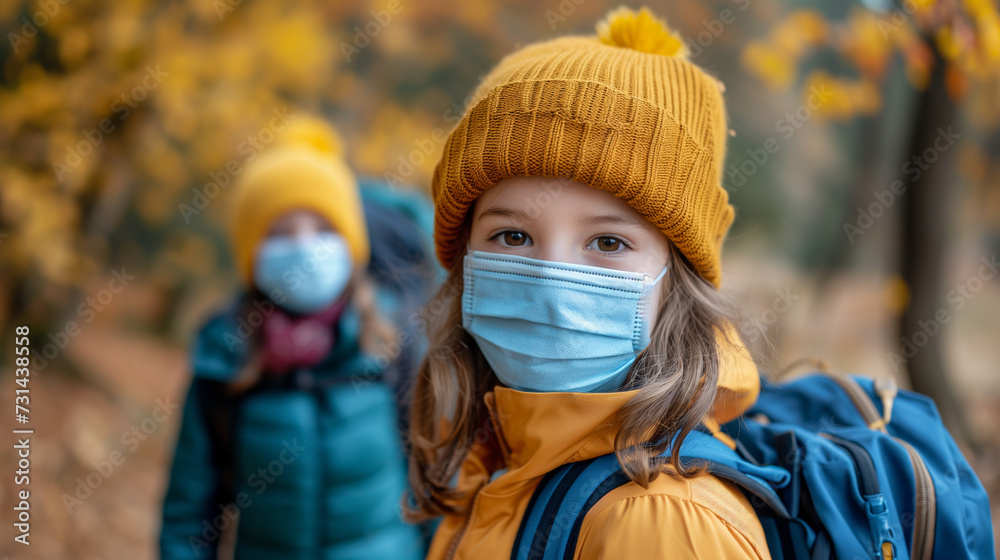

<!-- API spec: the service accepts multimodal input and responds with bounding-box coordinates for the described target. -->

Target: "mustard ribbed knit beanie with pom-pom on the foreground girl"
[432,8,733,287]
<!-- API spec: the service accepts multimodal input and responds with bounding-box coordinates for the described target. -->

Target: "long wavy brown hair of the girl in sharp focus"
[406,246,735,521]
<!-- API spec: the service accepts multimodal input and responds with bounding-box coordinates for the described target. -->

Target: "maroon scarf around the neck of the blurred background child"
[263,294,350,376]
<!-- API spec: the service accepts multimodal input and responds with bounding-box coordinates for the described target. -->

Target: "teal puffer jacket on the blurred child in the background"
[161,308,423,560]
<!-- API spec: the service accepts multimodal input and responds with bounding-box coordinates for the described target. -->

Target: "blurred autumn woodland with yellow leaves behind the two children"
[0,0,1000,558]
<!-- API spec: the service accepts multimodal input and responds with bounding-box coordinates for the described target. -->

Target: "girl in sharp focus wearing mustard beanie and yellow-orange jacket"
[409,9,769,560]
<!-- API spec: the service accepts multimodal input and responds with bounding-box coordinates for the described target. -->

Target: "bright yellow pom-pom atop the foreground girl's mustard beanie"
[597,6,689,60]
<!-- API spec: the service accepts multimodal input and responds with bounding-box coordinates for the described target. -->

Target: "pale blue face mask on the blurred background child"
[254,232,354,314]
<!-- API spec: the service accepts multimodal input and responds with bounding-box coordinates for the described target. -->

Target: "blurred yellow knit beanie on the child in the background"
[229,116,369,285]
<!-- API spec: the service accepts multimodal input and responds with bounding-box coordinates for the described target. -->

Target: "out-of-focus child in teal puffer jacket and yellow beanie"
[160,117,429,560]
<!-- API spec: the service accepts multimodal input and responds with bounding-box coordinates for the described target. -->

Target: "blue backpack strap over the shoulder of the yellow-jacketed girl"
[511,430,790,560]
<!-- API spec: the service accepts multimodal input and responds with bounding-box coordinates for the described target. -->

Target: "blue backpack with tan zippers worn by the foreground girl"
[511,373,996,560]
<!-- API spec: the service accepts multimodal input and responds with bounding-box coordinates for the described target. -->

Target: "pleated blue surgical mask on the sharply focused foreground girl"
[462,251,667,393]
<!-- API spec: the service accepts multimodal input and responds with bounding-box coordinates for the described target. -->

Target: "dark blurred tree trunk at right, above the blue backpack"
[899,42,980,452]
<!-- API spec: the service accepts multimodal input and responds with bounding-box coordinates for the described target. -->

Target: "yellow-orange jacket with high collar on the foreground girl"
[428,336,771,560]
